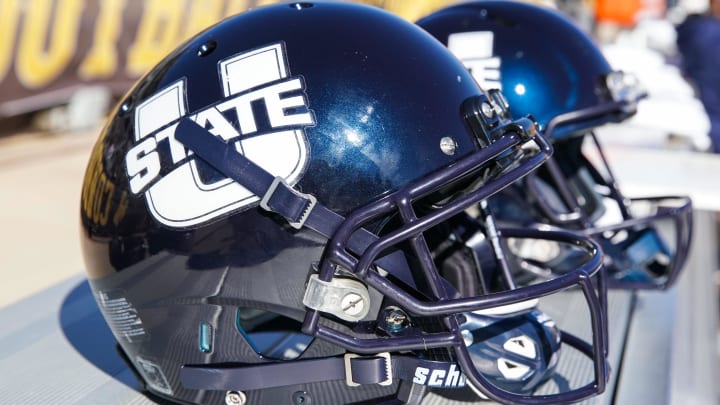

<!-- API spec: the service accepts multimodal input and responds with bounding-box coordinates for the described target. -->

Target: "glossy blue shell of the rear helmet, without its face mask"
[417,1,618,139]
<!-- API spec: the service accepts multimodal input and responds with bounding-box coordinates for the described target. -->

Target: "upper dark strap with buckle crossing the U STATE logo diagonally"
[175,118,415,287]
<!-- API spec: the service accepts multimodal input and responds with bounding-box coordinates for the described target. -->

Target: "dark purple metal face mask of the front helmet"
[303,153,606,404]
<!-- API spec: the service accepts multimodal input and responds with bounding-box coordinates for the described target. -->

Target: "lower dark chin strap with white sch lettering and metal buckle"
[180,353,465,391]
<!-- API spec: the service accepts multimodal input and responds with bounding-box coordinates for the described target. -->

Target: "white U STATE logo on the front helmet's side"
[125,43,315,228]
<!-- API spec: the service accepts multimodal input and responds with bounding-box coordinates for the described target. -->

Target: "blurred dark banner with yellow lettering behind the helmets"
[0,0,462,117]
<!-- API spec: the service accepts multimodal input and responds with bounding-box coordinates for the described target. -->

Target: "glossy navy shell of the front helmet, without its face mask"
[81,3,500,403]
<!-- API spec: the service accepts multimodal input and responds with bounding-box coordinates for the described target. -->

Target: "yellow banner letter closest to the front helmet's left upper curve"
[126,0,184,76]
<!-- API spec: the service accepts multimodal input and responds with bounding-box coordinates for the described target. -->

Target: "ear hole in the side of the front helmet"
[236,308,314,360]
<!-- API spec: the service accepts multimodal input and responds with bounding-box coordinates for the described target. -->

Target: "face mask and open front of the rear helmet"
[520,133,692,289]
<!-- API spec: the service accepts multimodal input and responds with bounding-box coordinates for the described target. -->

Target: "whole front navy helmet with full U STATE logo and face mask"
[81,2,607,404]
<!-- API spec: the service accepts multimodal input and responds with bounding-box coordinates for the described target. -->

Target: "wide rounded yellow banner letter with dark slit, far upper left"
[15,0,84,88]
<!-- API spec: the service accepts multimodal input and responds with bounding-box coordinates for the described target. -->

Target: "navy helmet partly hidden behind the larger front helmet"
[418,1,692,289]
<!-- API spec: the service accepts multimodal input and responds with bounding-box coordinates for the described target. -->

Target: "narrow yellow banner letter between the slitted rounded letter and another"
[78,0,125,80]
